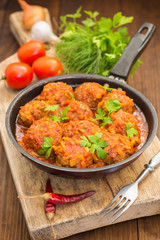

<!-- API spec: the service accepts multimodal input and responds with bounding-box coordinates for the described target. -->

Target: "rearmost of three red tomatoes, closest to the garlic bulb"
[17,40,46,65]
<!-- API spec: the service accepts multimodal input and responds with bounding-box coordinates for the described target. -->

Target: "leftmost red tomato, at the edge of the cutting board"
[5,62,33,89]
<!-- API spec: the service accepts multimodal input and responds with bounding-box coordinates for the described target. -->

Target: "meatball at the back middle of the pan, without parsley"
[74,82,106,109]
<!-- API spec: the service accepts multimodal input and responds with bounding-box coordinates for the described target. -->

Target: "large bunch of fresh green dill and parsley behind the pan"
[56,7,141,76]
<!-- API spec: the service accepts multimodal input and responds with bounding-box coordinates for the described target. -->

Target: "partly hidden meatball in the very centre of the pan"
[62,120,101,139]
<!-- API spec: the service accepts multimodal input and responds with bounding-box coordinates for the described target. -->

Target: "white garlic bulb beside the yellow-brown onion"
[31,21,60,43]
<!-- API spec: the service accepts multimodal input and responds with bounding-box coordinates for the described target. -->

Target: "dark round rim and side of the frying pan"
[5,74,158,174]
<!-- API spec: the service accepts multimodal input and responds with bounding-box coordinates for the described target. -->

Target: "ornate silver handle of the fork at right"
[136,152,160,184]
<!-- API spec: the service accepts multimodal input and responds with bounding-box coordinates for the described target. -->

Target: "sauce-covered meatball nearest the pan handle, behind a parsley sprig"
[98,89,134,113]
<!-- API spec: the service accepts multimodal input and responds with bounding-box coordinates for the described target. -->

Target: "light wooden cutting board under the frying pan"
[0,9,160,240]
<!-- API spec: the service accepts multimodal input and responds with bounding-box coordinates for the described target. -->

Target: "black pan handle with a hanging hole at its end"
[110,23,156,81]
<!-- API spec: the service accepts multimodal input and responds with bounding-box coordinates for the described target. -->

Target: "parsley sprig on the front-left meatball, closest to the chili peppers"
[38,137,53,159]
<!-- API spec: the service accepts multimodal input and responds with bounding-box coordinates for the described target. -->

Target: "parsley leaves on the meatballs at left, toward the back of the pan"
[44,105,69,122]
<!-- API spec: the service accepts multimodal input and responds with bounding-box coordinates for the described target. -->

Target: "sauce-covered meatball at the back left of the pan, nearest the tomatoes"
[37,82,74,106]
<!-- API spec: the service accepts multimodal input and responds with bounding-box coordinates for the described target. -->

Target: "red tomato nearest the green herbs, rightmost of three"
[32,56,63,79]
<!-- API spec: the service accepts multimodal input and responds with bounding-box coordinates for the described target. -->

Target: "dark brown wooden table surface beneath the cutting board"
[0,0,160,240]
